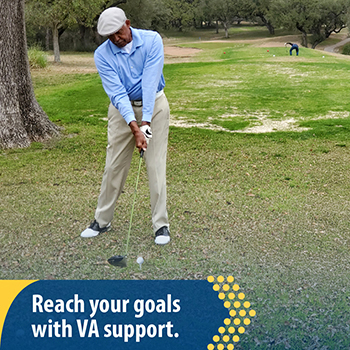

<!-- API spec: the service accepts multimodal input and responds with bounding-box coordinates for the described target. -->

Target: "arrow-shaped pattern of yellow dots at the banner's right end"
[207,276,256,350]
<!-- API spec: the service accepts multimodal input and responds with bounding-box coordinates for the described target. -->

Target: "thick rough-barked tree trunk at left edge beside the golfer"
[0,0,58,148]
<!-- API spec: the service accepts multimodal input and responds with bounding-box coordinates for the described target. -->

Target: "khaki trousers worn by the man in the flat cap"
[95,94,170,232]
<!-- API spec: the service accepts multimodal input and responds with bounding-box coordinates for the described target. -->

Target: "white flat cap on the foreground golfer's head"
[97,7,126,36]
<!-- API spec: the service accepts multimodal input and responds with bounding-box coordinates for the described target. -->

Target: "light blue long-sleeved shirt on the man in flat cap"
[94,28,165,124]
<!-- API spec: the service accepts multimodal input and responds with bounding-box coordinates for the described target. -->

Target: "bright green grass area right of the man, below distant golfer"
[165,43,350,130]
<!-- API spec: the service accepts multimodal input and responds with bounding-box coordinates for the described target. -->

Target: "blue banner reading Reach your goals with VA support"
[1,277,254,350]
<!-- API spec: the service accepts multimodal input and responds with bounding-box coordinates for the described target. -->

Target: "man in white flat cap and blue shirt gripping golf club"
[81,7,170,244]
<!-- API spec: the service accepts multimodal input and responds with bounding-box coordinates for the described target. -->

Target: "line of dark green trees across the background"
[26,0,350,60]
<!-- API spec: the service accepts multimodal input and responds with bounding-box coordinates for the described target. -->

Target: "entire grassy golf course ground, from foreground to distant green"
[0,40,350,350]
